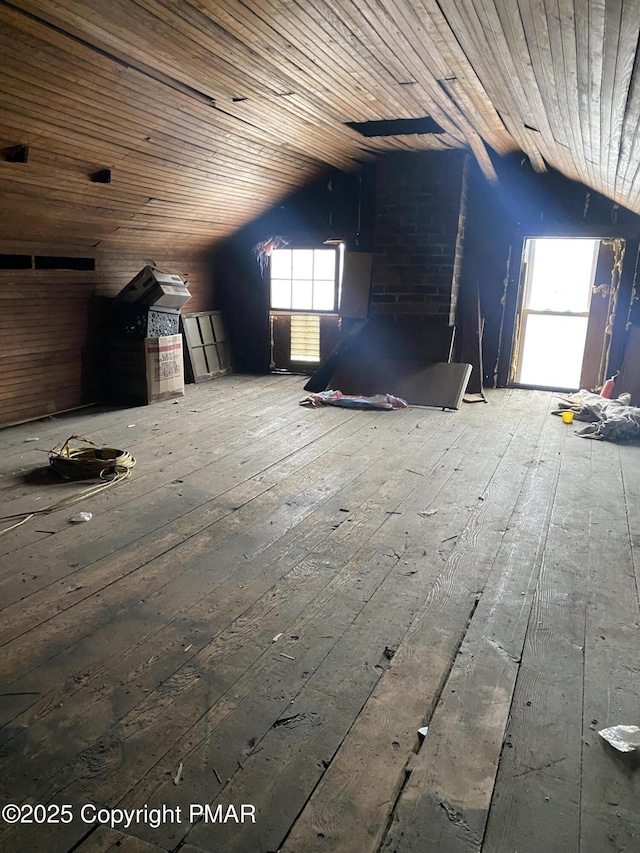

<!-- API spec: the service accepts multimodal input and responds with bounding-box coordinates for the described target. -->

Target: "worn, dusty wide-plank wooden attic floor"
[0,376,640,853]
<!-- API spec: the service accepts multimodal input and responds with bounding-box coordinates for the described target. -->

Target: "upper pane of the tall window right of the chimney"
[526,239,599,314]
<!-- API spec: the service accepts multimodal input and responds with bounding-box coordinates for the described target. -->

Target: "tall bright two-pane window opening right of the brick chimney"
[511,237,623,390]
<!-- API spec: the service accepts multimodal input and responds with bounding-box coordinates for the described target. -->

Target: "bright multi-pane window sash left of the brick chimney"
[271,249,339,311]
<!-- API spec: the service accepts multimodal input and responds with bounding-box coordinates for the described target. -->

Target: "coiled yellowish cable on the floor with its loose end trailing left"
[0,433,136,536]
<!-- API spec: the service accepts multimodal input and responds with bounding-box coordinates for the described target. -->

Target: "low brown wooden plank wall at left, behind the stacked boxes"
[0,243,215,426]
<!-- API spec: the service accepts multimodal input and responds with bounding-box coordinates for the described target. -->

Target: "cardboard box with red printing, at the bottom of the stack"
[111,335,184,403]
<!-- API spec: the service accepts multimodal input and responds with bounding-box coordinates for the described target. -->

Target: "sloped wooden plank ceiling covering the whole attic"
[0,0,640,248]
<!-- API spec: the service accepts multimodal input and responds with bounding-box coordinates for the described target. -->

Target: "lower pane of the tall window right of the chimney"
[518,314,588,388]
